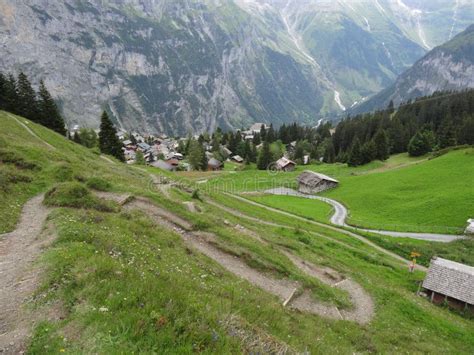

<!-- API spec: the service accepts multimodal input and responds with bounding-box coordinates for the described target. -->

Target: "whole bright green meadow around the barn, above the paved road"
[179,148,474,234]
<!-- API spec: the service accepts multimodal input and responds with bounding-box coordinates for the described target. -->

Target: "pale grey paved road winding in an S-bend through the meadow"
[265,187,465,243]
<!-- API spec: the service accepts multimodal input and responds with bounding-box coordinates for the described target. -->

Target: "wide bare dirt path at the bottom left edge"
[0,195,54,354]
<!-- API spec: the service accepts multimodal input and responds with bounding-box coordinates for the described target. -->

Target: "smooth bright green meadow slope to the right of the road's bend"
[325,148,474,233]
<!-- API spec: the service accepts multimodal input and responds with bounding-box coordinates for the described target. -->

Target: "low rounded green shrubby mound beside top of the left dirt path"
[44,182,118,212]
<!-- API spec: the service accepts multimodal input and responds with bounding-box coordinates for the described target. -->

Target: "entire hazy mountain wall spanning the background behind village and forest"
[0,0,474,134]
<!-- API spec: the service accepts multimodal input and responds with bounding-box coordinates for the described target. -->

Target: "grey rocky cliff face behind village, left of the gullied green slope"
[0,0,324,134]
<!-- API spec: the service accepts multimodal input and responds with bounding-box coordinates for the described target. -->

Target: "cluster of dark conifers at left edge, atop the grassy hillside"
[0,72,66,135]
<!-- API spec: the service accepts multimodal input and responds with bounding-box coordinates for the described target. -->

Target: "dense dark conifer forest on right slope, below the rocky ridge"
[332,90,474,165]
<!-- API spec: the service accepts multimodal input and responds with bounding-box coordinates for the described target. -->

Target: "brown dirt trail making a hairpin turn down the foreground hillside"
[100,193,374,324]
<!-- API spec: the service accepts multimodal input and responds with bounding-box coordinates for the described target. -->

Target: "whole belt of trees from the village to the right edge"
[206,90,474,169]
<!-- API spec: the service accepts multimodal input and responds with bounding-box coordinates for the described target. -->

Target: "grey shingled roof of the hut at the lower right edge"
[423,258,474,305]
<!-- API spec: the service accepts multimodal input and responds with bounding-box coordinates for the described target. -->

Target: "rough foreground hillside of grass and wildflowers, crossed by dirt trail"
[0,113,474,354]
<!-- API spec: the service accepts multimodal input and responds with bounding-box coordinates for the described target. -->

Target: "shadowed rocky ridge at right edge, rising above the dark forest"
[354,25,474,112]
